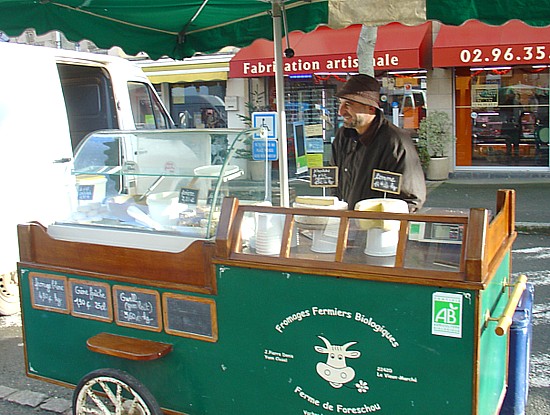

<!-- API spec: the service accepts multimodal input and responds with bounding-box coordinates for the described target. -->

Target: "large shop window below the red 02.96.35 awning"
[466,67,549,167]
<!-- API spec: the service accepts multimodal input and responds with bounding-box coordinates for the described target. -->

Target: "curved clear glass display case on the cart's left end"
[48,129,266,252]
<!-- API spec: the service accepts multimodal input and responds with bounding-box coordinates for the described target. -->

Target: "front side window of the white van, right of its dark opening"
[128,82,170,130]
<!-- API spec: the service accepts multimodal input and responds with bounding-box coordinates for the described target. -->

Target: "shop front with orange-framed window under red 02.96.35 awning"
[433,20,550,170]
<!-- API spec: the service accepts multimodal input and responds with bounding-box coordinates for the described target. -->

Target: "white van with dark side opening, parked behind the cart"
[0,42,174,314]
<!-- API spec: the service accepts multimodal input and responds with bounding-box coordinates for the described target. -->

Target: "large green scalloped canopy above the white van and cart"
[0,0,328,59]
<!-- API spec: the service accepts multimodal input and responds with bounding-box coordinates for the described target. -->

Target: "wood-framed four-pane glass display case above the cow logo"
[234,206,468,273]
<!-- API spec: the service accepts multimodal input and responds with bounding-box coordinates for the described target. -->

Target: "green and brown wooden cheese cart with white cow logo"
[18,129,525,415]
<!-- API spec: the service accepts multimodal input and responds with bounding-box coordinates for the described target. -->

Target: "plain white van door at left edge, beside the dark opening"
[0,43,74,273]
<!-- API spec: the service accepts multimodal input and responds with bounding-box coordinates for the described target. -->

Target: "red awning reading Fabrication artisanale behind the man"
[229,22,432,78]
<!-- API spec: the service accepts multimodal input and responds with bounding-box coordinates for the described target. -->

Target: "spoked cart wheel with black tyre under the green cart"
[73,369,162,415]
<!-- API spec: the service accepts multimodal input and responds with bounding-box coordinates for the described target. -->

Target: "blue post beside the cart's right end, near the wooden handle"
[500,283,535,415]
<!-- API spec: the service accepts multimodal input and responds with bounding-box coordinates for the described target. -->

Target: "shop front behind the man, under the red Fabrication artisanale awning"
[229,22,432,170]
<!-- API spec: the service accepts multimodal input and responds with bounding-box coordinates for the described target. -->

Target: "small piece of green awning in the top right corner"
[426,0,550,26]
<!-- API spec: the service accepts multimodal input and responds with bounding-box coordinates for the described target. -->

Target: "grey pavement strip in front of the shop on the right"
[424,175,550,234]
